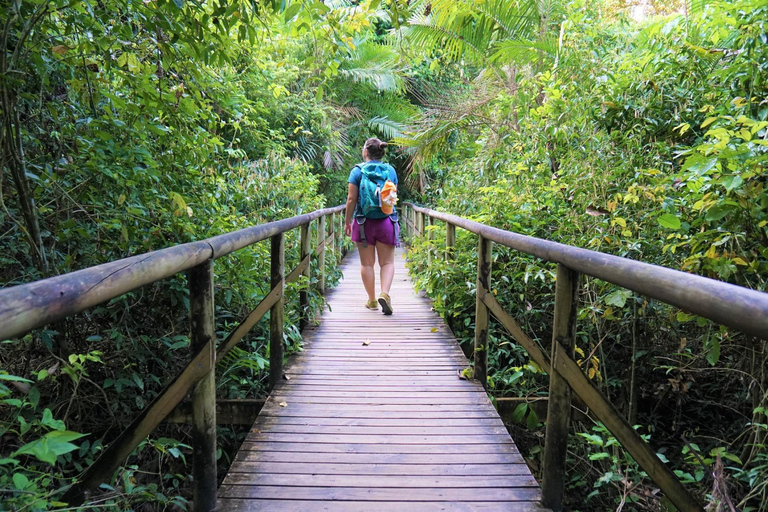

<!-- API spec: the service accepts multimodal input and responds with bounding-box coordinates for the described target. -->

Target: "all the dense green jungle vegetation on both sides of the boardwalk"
[0,0,768,511]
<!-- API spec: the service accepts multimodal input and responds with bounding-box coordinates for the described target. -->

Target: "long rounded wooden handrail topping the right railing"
[405,203,768,339]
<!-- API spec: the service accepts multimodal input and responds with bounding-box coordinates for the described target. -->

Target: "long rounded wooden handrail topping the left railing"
[0,205,345,340]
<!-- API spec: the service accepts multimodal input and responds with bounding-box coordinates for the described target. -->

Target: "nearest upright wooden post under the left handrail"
[189,259,216,512]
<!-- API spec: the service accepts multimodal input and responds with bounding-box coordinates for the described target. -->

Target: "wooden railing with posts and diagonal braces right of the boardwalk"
[403,203,768,512]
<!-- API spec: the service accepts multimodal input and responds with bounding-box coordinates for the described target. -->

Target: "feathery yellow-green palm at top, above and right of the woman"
[397,0,562,162]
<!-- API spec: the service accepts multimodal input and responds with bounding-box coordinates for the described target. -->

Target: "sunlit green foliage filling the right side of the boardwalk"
[403,0,768,510]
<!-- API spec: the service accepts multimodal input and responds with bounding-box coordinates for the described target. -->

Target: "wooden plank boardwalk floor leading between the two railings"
[218,250,544,511]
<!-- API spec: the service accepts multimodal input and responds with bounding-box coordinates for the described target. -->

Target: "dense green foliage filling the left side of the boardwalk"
[0,0,396,510]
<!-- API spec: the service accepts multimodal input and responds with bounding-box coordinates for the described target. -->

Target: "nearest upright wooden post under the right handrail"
[541,264,579,512]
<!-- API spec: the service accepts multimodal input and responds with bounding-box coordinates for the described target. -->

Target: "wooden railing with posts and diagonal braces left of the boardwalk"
[0,205,345,512]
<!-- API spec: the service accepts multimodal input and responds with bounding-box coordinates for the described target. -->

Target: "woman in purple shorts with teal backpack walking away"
[344,138,399,315]
